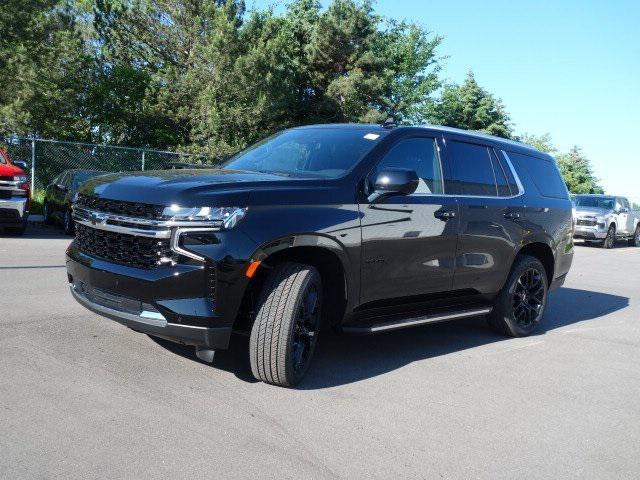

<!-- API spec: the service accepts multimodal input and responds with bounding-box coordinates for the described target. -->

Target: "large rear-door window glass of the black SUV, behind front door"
[446,141,497,197]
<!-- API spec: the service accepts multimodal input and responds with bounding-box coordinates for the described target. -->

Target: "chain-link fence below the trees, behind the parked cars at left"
[0,137,209,191]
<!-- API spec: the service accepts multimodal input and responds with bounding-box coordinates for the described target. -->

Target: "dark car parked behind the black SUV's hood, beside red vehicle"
[42,169,107,235]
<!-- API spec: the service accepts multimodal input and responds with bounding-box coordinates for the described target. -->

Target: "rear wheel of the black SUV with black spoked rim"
[487,255,549,337]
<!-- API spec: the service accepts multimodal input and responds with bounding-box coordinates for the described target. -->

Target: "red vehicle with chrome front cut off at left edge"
[0,148,31,235]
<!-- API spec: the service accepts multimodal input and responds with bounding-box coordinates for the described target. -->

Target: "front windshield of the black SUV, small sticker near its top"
[224,128,387,178]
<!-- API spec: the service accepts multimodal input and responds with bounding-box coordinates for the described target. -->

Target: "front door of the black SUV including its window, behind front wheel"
[359,136,458,304]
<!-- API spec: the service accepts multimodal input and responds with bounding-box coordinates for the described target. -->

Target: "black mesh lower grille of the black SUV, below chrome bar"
[76,224,175,268]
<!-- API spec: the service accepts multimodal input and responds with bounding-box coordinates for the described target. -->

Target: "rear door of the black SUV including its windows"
[445,136,524,294]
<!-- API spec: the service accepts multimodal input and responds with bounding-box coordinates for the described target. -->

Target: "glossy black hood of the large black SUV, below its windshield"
[80,169,340,207]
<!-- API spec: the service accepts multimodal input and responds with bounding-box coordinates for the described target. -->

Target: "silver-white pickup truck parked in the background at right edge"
[571,195,640,248]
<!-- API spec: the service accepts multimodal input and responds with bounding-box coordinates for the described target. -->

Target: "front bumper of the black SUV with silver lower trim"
[67,251,233,349]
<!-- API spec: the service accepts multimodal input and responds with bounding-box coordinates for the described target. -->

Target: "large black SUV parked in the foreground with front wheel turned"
[67,125,573,386]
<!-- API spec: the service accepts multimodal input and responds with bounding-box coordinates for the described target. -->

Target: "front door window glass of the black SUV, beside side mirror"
[377,138,443,195]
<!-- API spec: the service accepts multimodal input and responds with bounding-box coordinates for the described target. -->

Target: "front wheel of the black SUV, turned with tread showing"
[249,262,322,387]
